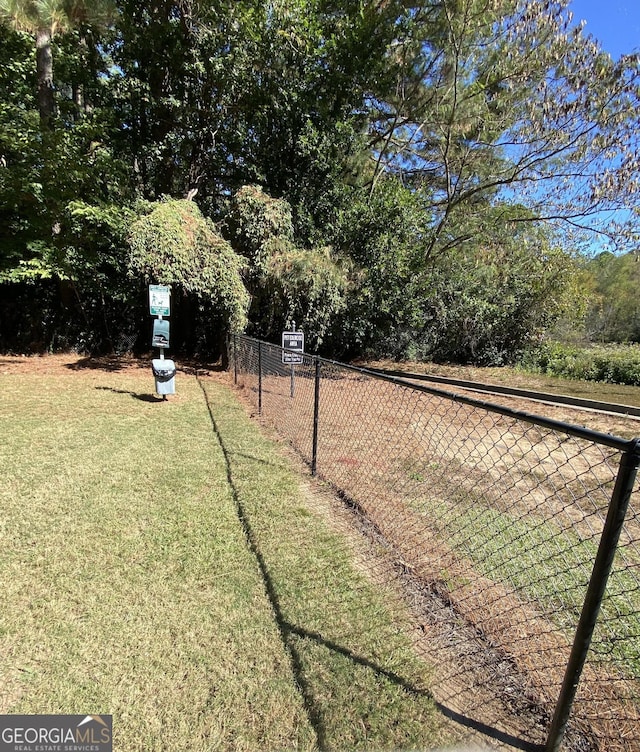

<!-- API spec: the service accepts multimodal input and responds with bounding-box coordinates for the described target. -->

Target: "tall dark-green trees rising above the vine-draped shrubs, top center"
[107,0,392,212]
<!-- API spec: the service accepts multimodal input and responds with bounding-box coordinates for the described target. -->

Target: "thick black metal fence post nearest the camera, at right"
[545,439,640,752]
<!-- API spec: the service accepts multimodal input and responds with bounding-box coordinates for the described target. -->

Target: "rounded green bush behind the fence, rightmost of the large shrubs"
[417,207,574,365]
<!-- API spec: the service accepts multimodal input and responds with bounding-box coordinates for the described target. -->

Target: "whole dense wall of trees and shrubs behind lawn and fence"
[0,0,640,364]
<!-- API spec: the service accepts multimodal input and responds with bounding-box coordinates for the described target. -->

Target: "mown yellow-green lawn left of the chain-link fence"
[0,368,446,752]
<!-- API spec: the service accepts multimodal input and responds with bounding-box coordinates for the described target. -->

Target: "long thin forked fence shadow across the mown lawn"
[198,380,541,752]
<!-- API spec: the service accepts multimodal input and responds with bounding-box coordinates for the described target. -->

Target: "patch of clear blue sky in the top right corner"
[569,0,640,60]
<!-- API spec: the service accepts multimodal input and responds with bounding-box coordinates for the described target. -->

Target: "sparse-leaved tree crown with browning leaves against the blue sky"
[364,0,640,254]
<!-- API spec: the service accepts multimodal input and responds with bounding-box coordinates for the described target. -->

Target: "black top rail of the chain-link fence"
[237,334,640,456]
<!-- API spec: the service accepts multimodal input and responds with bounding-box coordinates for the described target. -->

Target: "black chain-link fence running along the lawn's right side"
[230,336,640,750]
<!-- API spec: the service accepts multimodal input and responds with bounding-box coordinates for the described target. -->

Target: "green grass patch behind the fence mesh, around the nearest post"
[432,505,640,680]
